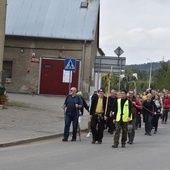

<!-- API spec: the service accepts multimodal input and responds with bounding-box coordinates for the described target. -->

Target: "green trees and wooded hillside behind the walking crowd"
[102,61,170,93]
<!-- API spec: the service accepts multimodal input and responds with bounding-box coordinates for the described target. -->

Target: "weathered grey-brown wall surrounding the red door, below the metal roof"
[4,36,97,96]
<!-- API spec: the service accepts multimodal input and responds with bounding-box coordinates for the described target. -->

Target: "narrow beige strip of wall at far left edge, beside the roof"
[0,0,7,82]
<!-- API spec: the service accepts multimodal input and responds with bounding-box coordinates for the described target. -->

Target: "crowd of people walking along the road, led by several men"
[63,87,170,148]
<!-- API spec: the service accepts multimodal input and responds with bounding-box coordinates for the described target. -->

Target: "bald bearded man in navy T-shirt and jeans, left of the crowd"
[62,87,83,142]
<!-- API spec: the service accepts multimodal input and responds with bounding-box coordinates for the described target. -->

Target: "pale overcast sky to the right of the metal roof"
[100,0,170,65]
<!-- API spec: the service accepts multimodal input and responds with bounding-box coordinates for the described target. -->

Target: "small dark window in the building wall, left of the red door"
[2,61,12,84]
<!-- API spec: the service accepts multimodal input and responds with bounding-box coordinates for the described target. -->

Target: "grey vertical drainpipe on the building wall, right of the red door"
[80,40,86,91]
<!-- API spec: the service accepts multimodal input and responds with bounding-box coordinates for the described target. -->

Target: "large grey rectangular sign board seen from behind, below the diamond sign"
[94,56,126,74]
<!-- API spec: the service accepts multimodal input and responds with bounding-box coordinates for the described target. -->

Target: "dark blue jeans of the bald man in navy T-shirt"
[64,114,78,139]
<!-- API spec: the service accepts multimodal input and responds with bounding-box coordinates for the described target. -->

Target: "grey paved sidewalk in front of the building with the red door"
[0,93,88,147]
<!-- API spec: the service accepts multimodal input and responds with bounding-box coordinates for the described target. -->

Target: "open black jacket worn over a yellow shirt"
[90,95,107,115]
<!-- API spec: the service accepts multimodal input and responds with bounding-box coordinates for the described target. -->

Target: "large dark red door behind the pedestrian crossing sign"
[40,59,79,95]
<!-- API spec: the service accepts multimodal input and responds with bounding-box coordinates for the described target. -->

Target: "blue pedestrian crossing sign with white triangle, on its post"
[64,58,76,93]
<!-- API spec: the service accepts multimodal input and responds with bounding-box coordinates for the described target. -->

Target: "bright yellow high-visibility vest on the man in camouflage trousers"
[116,99,132,122]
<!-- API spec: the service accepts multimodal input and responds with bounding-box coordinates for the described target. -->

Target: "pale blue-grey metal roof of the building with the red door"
[6,0,100,40]
